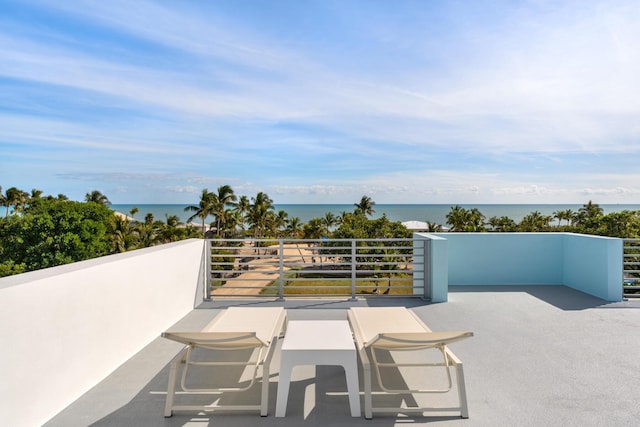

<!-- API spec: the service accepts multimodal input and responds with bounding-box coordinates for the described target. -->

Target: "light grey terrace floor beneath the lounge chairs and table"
[42,286,640,427]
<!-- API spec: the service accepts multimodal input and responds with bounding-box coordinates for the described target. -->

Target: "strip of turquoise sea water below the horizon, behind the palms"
[111,204,640,225]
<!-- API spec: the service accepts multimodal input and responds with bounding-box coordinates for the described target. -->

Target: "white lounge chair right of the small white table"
[348,307,473,419]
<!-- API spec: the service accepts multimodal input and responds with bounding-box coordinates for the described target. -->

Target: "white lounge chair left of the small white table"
[162,307,286,417]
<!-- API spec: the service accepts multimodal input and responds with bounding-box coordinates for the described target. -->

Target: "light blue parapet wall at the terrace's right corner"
[416,233,622,301]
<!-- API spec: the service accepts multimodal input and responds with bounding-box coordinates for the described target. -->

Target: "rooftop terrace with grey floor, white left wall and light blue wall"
[0,233,640,427]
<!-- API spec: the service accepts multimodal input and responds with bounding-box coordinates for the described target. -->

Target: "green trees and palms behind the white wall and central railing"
[0,185,390,277]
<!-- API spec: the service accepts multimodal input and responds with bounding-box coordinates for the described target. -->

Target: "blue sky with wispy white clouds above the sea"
[0,0,640,204]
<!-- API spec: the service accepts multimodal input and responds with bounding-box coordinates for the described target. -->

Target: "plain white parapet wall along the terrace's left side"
[0,239,204,426]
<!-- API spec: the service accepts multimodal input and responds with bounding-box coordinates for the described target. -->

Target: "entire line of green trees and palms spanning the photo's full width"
[0,185,640,277]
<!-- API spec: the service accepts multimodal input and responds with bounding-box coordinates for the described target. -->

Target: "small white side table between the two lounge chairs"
[276,320,361,417]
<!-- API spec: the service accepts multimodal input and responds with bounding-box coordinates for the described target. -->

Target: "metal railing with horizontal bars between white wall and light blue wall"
[206,239,430,299]
